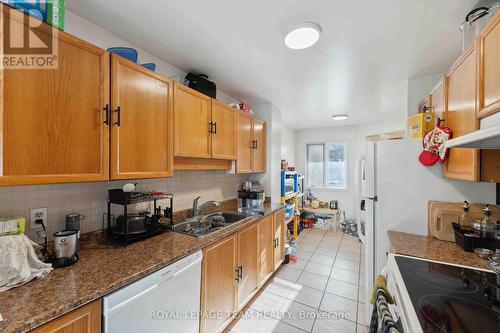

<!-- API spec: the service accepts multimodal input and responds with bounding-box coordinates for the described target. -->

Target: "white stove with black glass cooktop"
[388,255,500,333]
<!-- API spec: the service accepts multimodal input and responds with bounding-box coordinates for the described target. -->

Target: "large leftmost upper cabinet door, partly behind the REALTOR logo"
[0,18,109,185]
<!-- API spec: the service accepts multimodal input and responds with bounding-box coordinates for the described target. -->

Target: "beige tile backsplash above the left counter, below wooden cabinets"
[0,171,247,242]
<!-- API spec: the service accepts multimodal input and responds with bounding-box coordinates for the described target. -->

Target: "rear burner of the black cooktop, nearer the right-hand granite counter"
[405,262,478,293]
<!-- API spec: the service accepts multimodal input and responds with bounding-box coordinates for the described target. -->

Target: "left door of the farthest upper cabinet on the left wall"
[236,112,254,173]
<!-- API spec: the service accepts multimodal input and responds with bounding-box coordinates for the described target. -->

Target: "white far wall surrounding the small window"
[295,115,406,218]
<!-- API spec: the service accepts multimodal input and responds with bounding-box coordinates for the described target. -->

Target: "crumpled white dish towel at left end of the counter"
[0,234,53,292]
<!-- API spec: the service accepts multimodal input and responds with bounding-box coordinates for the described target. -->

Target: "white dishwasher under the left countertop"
[103,251,202,333]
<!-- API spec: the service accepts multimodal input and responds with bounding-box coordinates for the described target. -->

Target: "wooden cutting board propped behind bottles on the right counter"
[428,201,500,242]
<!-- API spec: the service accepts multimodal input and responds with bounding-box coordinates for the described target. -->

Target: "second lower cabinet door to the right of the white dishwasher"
[238,223,259,310]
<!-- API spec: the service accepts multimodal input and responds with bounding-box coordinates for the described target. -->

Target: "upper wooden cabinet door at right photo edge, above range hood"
[478,12,500,118]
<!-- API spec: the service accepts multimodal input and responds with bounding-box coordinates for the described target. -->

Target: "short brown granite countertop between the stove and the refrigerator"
[387,231,489,269]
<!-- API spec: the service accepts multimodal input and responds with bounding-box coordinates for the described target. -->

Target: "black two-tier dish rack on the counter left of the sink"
[107,189,174,244]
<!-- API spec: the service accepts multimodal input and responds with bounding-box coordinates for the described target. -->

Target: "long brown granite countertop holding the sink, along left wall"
[0,204,282,333]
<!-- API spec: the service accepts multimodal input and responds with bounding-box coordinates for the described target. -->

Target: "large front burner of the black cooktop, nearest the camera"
[418,294,500,333]
